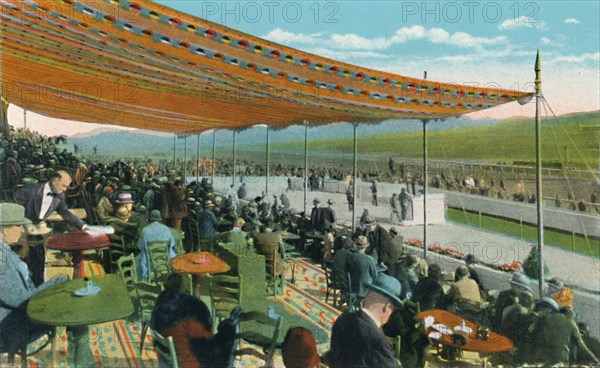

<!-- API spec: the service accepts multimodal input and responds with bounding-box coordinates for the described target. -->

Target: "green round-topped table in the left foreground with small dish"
[27,275,134,367]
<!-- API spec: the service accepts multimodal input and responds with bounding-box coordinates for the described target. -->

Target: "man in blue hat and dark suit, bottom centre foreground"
[328,274,402,368]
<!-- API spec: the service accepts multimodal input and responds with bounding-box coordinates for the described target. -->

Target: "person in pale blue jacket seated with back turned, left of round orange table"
[136,210,177,281]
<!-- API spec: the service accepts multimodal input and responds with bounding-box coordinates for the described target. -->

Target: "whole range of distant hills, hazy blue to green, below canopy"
[69,111,600,169]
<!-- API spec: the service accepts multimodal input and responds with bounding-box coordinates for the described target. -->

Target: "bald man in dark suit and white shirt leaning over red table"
[15,171,86,286]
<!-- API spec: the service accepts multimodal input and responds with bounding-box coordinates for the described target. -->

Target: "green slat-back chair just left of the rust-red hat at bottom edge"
[237,311,283,368]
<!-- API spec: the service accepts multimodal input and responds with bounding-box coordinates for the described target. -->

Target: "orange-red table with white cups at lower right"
[415,309,513,353]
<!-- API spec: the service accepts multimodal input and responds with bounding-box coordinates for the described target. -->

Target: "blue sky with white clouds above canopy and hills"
[9,0,600,135]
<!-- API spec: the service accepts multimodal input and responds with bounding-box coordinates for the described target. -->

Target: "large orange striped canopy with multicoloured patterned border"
[0,0,526,133]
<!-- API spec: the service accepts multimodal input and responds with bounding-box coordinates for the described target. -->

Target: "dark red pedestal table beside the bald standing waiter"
[47,231,110,278]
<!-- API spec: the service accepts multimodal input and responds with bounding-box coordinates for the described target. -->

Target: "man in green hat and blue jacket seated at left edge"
[0,203,68,353]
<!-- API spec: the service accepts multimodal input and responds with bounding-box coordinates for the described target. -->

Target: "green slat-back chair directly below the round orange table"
[207,275,242,326]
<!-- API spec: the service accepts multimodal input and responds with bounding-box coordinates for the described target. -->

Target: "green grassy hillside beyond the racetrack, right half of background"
[272,112,600,170]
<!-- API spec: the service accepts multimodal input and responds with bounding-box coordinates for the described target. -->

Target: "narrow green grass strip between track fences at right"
[446,208,600,257]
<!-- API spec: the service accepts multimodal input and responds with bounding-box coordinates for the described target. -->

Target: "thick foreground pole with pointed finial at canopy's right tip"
[534,50,544,298]
